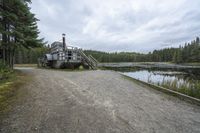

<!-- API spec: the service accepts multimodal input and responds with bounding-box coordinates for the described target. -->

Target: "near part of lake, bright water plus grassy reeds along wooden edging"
[122,69,200,98]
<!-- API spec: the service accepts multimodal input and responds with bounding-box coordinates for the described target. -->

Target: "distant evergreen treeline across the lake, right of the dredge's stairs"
[85,37,200,63]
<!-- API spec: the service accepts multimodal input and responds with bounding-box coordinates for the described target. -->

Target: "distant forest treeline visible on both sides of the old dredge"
[15,37,200,64]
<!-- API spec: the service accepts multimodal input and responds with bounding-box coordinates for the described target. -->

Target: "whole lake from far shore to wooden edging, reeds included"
[101,63,200,99]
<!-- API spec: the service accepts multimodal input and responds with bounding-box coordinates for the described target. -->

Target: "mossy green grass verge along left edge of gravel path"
[0,71,30,115]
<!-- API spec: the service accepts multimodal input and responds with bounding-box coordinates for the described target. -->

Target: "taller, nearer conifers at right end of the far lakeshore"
[147,37,200,63]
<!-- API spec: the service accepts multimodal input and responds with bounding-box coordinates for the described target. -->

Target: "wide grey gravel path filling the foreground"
[0,68,200,133]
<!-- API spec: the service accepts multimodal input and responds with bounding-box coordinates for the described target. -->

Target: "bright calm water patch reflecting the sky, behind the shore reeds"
[124,70,199,87]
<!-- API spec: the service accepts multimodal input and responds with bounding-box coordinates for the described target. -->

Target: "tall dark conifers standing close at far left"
[0,0,44,68]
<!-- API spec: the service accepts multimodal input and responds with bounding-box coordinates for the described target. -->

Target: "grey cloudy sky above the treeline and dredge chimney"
[31,0,200,52]
